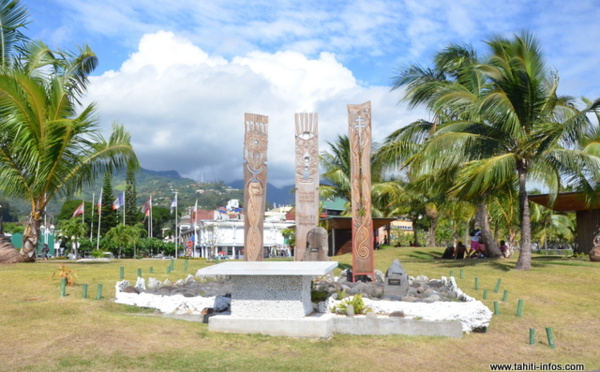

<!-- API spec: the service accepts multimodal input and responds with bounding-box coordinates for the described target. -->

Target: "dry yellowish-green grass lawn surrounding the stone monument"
[0,248,600,372]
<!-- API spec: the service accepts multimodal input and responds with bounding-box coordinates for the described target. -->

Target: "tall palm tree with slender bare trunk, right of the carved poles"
[406,33,600,270]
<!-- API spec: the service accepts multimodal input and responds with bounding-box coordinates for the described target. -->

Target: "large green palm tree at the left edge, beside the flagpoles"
[0,2,137,262]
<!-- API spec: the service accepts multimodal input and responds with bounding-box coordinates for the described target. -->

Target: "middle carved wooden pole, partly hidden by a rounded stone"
[295,113,319,261]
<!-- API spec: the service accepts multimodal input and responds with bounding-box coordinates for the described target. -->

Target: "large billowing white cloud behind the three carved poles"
[87,32,414,185]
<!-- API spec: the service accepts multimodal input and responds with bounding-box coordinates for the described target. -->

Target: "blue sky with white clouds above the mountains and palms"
[22,0,600,186]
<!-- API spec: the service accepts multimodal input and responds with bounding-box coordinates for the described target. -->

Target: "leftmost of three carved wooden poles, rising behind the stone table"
[244,114,269,261]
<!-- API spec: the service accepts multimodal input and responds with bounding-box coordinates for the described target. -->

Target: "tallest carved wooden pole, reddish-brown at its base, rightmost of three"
[348,101,375,278]
